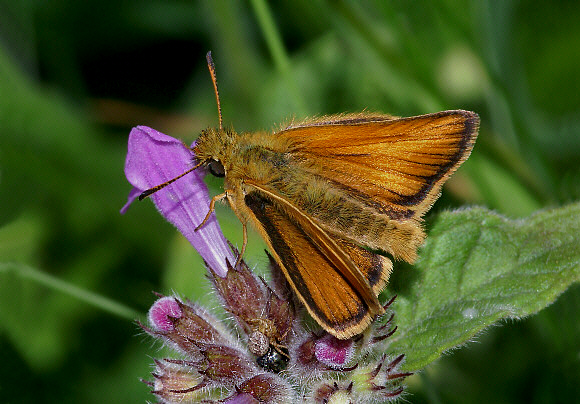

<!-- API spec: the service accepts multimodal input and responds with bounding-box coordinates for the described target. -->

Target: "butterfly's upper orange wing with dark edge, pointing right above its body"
[282,110,479,220]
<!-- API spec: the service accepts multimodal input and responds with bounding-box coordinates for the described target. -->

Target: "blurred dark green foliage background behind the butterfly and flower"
[0,0,580,403]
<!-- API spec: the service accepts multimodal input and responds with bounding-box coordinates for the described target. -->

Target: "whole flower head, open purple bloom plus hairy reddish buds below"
[121,126,410,404]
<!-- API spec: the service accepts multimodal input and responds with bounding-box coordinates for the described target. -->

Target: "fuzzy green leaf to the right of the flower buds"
[390,203,580,371]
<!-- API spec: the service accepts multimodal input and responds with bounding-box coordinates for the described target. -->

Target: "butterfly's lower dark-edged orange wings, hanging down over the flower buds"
[245,190,392,339]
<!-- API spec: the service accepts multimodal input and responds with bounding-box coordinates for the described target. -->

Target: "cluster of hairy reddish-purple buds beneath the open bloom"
[142,260,411,404]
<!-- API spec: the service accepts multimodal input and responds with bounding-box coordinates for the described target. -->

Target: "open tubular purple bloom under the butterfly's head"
[121,126,236,277]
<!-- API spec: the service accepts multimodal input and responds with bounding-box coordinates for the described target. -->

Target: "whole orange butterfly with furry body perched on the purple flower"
[141,53,479,339]
